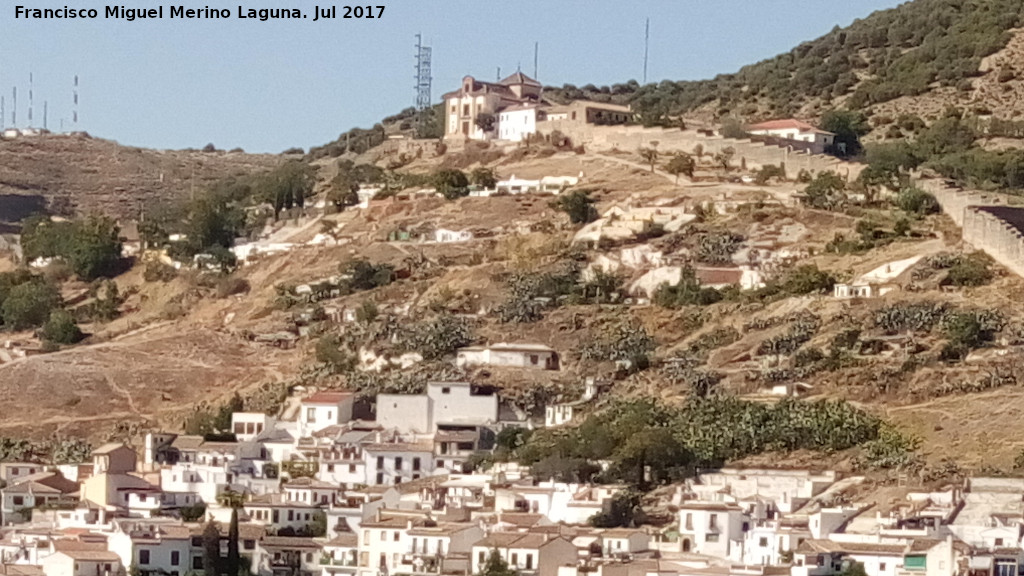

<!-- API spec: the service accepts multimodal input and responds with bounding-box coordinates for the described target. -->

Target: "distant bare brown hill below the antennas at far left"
[0,135,281,221]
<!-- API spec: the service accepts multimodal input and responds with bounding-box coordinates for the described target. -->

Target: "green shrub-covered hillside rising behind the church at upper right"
[631,0,1024,127]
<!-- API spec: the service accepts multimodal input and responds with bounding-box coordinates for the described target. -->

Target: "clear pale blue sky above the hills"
[0,0,899,152]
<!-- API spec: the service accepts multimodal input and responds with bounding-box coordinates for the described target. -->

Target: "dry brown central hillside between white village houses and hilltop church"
[0,136,1024,467]
